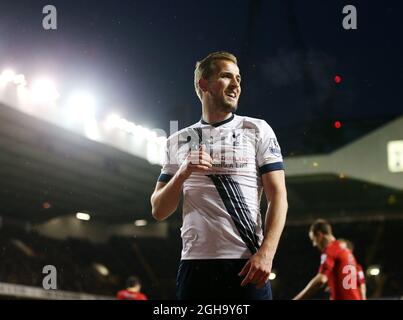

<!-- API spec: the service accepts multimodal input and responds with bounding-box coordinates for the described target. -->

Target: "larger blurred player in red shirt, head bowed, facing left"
[294,219,362,300]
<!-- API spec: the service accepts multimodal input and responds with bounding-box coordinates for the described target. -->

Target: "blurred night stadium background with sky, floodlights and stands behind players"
[0,0,403,299]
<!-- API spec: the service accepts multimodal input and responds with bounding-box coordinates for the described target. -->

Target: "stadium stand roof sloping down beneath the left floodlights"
[0,105,160,222]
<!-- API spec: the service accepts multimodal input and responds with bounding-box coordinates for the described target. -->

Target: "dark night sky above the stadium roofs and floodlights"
[0,0,403,140]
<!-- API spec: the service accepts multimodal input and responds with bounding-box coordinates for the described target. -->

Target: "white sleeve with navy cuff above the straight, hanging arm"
[257,121,284,175]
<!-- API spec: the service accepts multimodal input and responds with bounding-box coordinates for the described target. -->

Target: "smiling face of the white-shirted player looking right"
[208,60,241,112]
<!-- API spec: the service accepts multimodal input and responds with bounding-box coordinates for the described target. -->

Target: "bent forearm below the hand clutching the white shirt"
[151,172,186,221]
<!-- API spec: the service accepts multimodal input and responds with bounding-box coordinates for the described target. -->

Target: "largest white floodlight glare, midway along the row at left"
[66,92,95,122]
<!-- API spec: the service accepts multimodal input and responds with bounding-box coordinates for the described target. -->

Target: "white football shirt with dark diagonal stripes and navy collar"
[158,115,284,259]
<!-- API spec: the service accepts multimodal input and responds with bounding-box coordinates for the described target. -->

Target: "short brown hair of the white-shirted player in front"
[194,51,238,101]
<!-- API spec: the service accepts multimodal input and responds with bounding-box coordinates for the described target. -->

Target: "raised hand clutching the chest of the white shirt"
[179,145,213,178]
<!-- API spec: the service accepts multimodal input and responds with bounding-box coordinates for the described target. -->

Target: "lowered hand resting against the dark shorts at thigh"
[238,252,273,289]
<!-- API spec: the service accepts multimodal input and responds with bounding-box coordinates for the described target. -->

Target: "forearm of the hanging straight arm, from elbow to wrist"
[259,190,288,259]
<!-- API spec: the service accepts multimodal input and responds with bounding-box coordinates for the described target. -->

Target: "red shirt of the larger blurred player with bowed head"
[319,240,361,300]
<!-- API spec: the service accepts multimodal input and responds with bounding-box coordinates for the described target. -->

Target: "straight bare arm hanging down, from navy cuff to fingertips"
[239,170,288,288]
